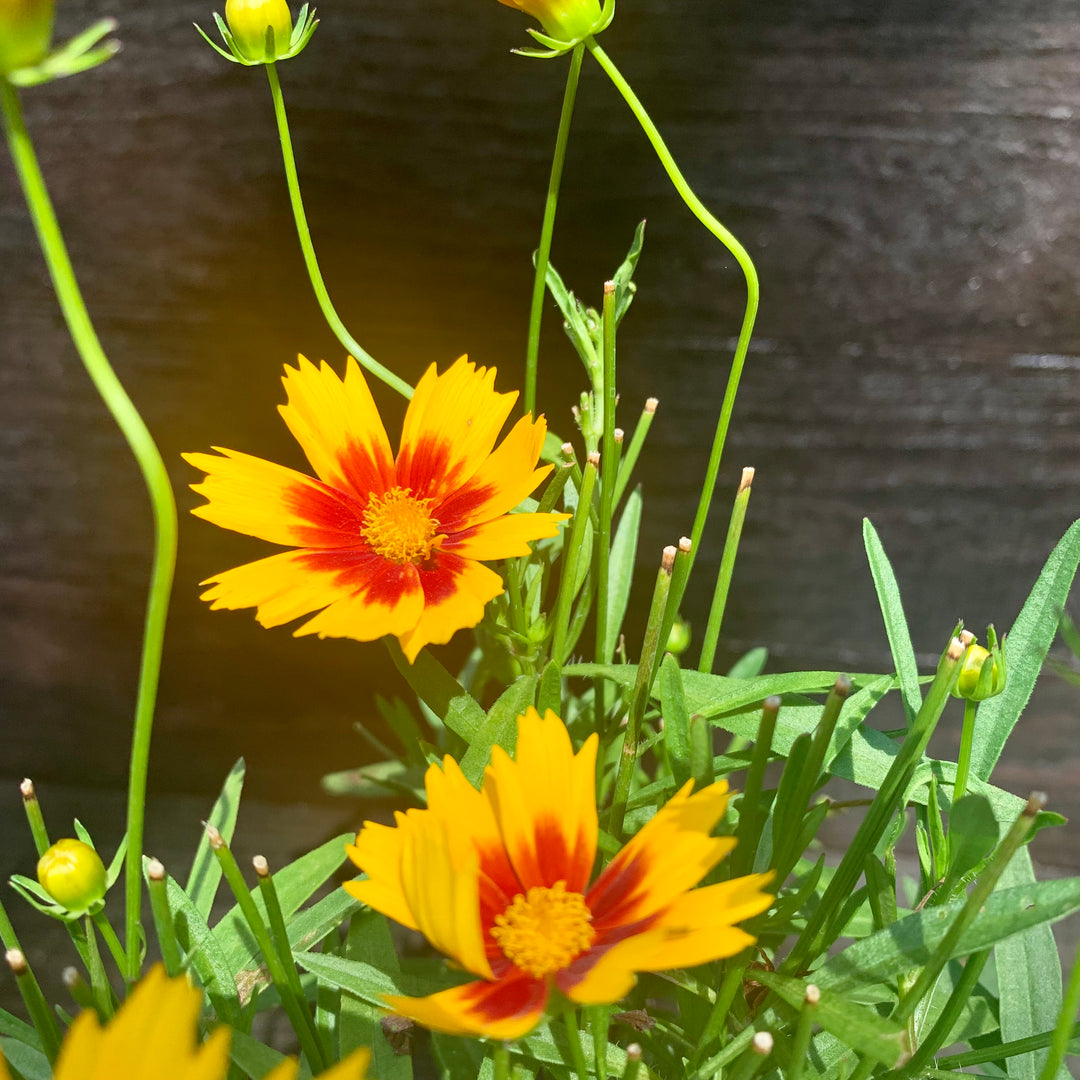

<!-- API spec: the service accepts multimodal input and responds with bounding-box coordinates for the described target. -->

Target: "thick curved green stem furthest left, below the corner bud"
[0,79,176,981]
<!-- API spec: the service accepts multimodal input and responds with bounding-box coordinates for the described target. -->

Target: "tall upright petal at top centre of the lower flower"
[484,707,598,892]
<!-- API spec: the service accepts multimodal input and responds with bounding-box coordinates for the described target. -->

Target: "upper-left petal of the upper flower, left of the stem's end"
[279,356,394,496]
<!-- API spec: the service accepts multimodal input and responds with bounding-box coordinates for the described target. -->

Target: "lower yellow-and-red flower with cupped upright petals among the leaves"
[346,708,772,1039]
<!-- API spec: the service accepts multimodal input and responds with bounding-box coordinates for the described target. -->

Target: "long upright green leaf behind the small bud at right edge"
[971,522,1080,780]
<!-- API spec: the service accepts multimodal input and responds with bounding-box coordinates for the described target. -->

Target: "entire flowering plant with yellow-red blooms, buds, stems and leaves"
[0,0,1080,1080]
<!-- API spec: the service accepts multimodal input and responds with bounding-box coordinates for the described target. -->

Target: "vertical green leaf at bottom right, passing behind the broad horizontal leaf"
[990,846,1076,1080]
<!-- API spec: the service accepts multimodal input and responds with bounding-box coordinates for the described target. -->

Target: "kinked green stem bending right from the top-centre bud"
[584,38,759,611]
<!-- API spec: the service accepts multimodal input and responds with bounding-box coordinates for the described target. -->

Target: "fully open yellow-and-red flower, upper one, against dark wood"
[184,356,567,662]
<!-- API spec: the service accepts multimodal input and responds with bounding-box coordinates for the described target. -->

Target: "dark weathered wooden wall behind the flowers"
[0,0,1080,860]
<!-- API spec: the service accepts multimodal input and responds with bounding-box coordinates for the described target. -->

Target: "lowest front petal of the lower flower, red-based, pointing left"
[386,972,548,1039]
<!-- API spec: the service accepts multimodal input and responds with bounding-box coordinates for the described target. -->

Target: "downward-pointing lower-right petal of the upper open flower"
[399,552,502,663]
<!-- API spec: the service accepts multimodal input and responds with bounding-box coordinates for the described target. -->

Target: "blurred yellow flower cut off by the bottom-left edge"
[0,964,370,1080]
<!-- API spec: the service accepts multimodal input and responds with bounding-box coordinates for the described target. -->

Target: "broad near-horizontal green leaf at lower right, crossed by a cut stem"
[813,876,1080,993]
